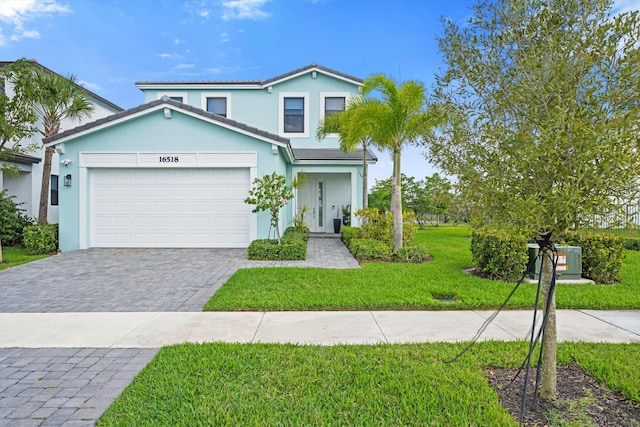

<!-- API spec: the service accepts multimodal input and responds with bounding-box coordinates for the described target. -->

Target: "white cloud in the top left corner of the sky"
[0,0,71,46]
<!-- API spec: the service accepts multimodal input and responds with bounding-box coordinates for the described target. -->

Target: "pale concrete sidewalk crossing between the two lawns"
[0,310,640,348]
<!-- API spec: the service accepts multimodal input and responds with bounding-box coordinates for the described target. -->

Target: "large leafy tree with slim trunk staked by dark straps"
[431,0,640,398]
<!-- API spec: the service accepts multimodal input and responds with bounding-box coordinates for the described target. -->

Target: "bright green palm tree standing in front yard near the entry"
[318,74,436,252]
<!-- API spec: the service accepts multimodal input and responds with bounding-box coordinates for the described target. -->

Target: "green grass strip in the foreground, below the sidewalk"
[97,342,640,427]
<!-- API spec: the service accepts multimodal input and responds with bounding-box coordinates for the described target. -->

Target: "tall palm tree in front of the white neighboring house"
[34,69,93,224]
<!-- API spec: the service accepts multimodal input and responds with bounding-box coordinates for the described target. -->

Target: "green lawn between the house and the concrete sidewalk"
[204,227,640,311]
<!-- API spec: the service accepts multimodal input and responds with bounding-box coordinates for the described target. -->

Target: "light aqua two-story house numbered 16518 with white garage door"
[45,64,377,251]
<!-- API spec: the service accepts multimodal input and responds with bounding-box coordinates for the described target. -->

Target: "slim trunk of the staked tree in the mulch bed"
[540,247,558,400]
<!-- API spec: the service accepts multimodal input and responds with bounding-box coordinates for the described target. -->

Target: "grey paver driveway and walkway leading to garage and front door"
[0,238,359,313]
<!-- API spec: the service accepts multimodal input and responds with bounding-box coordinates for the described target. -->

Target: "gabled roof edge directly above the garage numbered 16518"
[43,96,291,146]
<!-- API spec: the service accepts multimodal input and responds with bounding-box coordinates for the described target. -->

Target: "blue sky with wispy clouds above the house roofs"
[0,0,640,187]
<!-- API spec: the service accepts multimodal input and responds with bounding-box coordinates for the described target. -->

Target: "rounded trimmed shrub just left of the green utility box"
[471,228,529,282]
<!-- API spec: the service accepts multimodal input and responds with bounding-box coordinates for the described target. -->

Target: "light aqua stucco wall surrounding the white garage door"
[59,109,291,251]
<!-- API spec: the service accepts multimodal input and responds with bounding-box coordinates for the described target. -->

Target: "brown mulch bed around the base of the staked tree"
[486,365,640,427]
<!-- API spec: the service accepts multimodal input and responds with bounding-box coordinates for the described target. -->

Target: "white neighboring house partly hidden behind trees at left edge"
[0,61,122,224]
